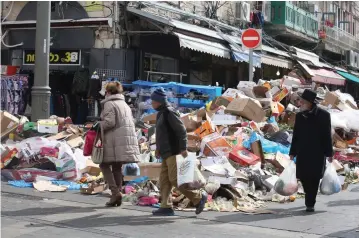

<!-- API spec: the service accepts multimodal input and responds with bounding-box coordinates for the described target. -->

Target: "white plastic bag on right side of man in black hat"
[320,163,342,195]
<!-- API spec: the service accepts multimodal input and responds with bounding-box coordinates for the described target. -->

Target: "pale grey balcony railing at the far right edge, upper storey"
[324,26,359,50]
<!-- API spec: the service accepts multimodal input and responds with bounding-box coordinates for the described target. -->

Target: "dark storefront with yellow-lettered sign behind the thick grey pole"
[2,2,129,124]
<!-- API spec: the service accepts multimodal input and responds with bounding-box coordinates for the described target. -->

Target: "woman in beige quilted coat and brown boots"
[100,82,139,207]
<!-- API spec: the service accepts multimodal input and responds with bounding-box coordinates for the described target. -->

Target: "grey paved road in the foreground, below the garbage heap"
[1,183,359,238]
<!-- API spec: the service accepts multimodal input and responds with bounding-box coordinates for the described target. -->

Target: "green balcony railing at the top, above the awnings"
[271,1,319,39]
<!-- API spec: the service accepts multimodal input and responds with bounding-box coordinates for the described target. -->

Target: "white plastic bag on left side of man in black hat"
[274,161,298,196]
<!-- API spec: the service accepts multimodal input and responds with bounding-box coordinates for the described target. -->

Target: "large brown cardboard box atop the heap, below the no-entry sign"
[225,98,265,122]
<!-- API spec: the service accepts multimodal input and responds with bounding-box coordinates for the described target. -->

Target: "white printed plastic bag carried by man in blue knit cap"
[176,155,206,190]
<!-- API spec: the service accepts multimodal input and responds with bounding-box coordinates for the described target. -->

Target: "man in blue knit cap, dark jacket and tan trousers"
[151,88,207,216]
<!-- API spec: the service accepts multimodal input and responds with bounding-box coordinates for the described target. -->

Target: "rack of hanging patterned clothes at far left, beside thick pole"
[1,74,28,115]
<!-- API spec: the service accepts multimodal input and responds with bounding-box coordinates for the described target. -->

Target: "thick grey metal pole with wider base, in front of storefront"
[31,1,51,121]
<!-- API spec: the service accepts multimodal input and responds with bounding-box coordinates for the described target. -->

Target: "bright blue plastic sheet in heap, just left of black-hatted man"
[243,132,290,155]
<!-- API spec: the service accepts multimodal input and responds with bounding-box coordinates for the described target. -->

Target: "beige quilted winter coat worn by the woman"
[100,94,139,163]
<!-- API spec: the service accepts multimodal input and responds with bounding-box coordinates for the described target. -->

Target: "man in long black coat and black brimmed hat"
[289,89,333,212]
